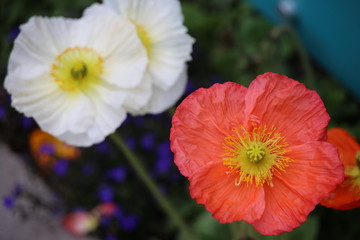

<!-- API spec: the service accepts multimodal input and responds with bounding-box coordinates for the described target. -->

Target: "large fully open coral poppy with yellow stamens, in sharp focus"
[170,73,344,235]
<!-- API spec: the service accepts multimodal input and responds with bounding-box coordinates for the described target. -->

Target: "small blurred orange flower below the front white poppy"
[29,129,80,169]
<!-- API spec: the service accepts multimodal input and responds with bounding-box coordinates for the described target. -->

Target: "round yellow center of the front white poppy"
[51,47,103,92]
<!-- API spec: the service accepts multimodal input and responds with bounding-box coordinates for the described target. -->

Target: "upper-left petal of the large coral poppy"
[170,83,247,176]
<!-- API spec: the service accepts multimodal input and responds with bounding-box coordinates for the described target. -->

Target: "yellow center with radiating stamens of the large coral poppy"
[223,127,292,186]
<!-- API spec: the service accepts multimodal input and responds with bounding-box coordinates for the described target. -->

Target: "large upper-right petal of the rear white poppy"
[86,0,194,90]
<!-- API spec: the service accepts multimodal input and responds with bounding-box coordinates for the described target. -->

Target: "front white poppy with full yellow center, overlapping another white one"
[5,15,151,146]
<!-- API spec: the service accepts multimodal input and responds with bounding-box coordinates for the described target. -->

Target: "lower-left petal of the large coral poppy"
[190,162,265,223]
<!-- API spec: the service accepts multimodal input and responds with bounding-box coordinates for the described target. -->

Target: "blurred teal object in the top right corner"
[248,0,360,100]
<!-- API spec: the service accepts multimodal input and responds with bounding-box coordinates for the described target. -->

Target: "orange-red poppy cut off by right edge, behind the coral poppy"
[320,128,360,210]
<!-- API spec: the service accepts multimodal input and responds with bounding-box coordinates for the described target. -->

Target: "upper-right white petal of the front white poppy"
[78,13,148,88]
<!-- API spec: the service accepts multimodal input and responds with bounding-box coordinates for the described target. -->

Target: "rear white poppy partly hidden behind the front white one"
[85,0,194,115]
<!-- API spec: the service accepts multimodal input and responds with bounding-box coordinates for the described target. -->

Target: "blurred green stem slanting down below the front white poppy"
[110,133,195,240]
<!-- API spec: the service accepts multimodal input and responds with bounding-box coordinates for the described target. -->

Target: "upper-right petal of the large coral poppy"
[245,73,330,145]
